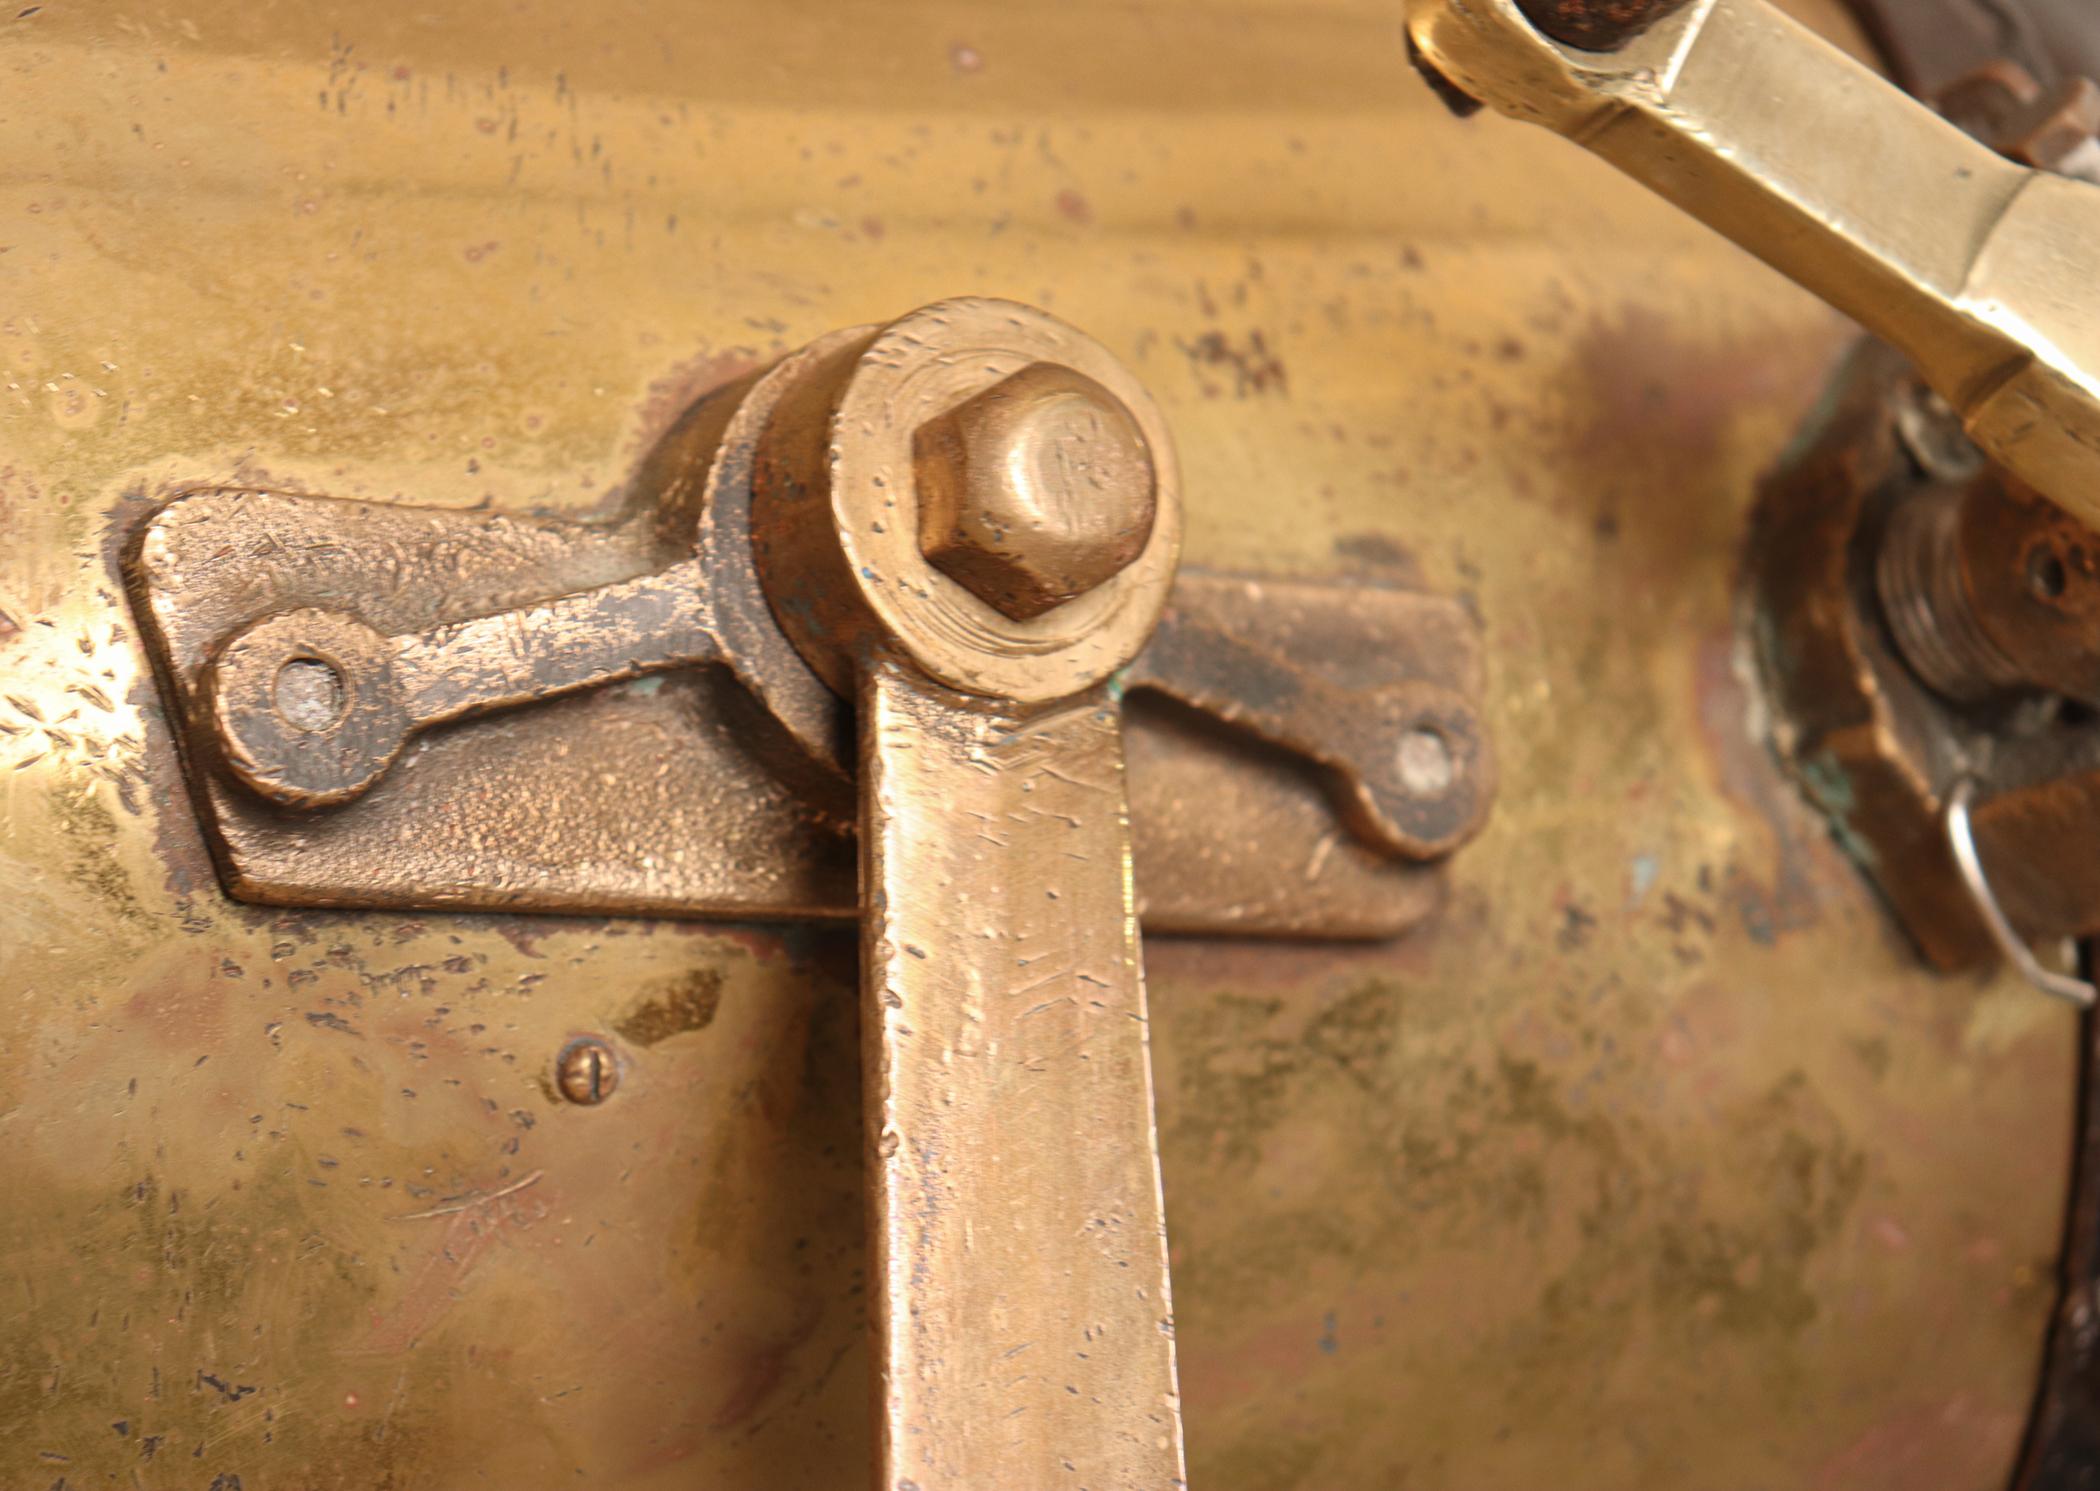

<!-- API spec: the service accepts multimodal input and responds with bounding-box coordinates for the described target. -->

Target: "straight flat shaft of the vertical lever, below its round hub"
[861,676,1180,1491]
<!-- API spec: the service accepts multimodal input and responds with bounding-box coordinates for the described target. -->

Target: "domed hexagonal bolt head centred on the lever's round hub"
[914,363,1159,622]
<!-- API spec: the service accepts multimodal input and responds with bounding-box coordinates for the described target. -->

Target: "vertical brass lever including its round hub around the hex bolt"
[752,300,1187,1491]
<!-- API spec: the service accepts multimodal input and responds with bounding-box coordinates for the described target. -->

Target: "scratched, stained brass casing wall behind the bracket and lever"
[0,0,2075,1491]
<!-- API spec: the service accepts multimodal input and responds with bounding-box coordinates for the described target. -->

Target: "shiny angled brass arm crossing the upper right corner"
[1407,0,2100,527]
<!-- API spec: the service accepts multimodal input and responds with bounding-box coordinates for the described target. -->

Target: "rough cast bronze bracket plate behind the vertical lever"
[128,489,1493,939]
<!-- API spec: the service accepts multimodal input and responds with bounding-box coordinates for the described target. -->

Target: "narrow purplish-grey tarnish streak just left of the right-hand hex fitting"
[1693,632,1827,943]
